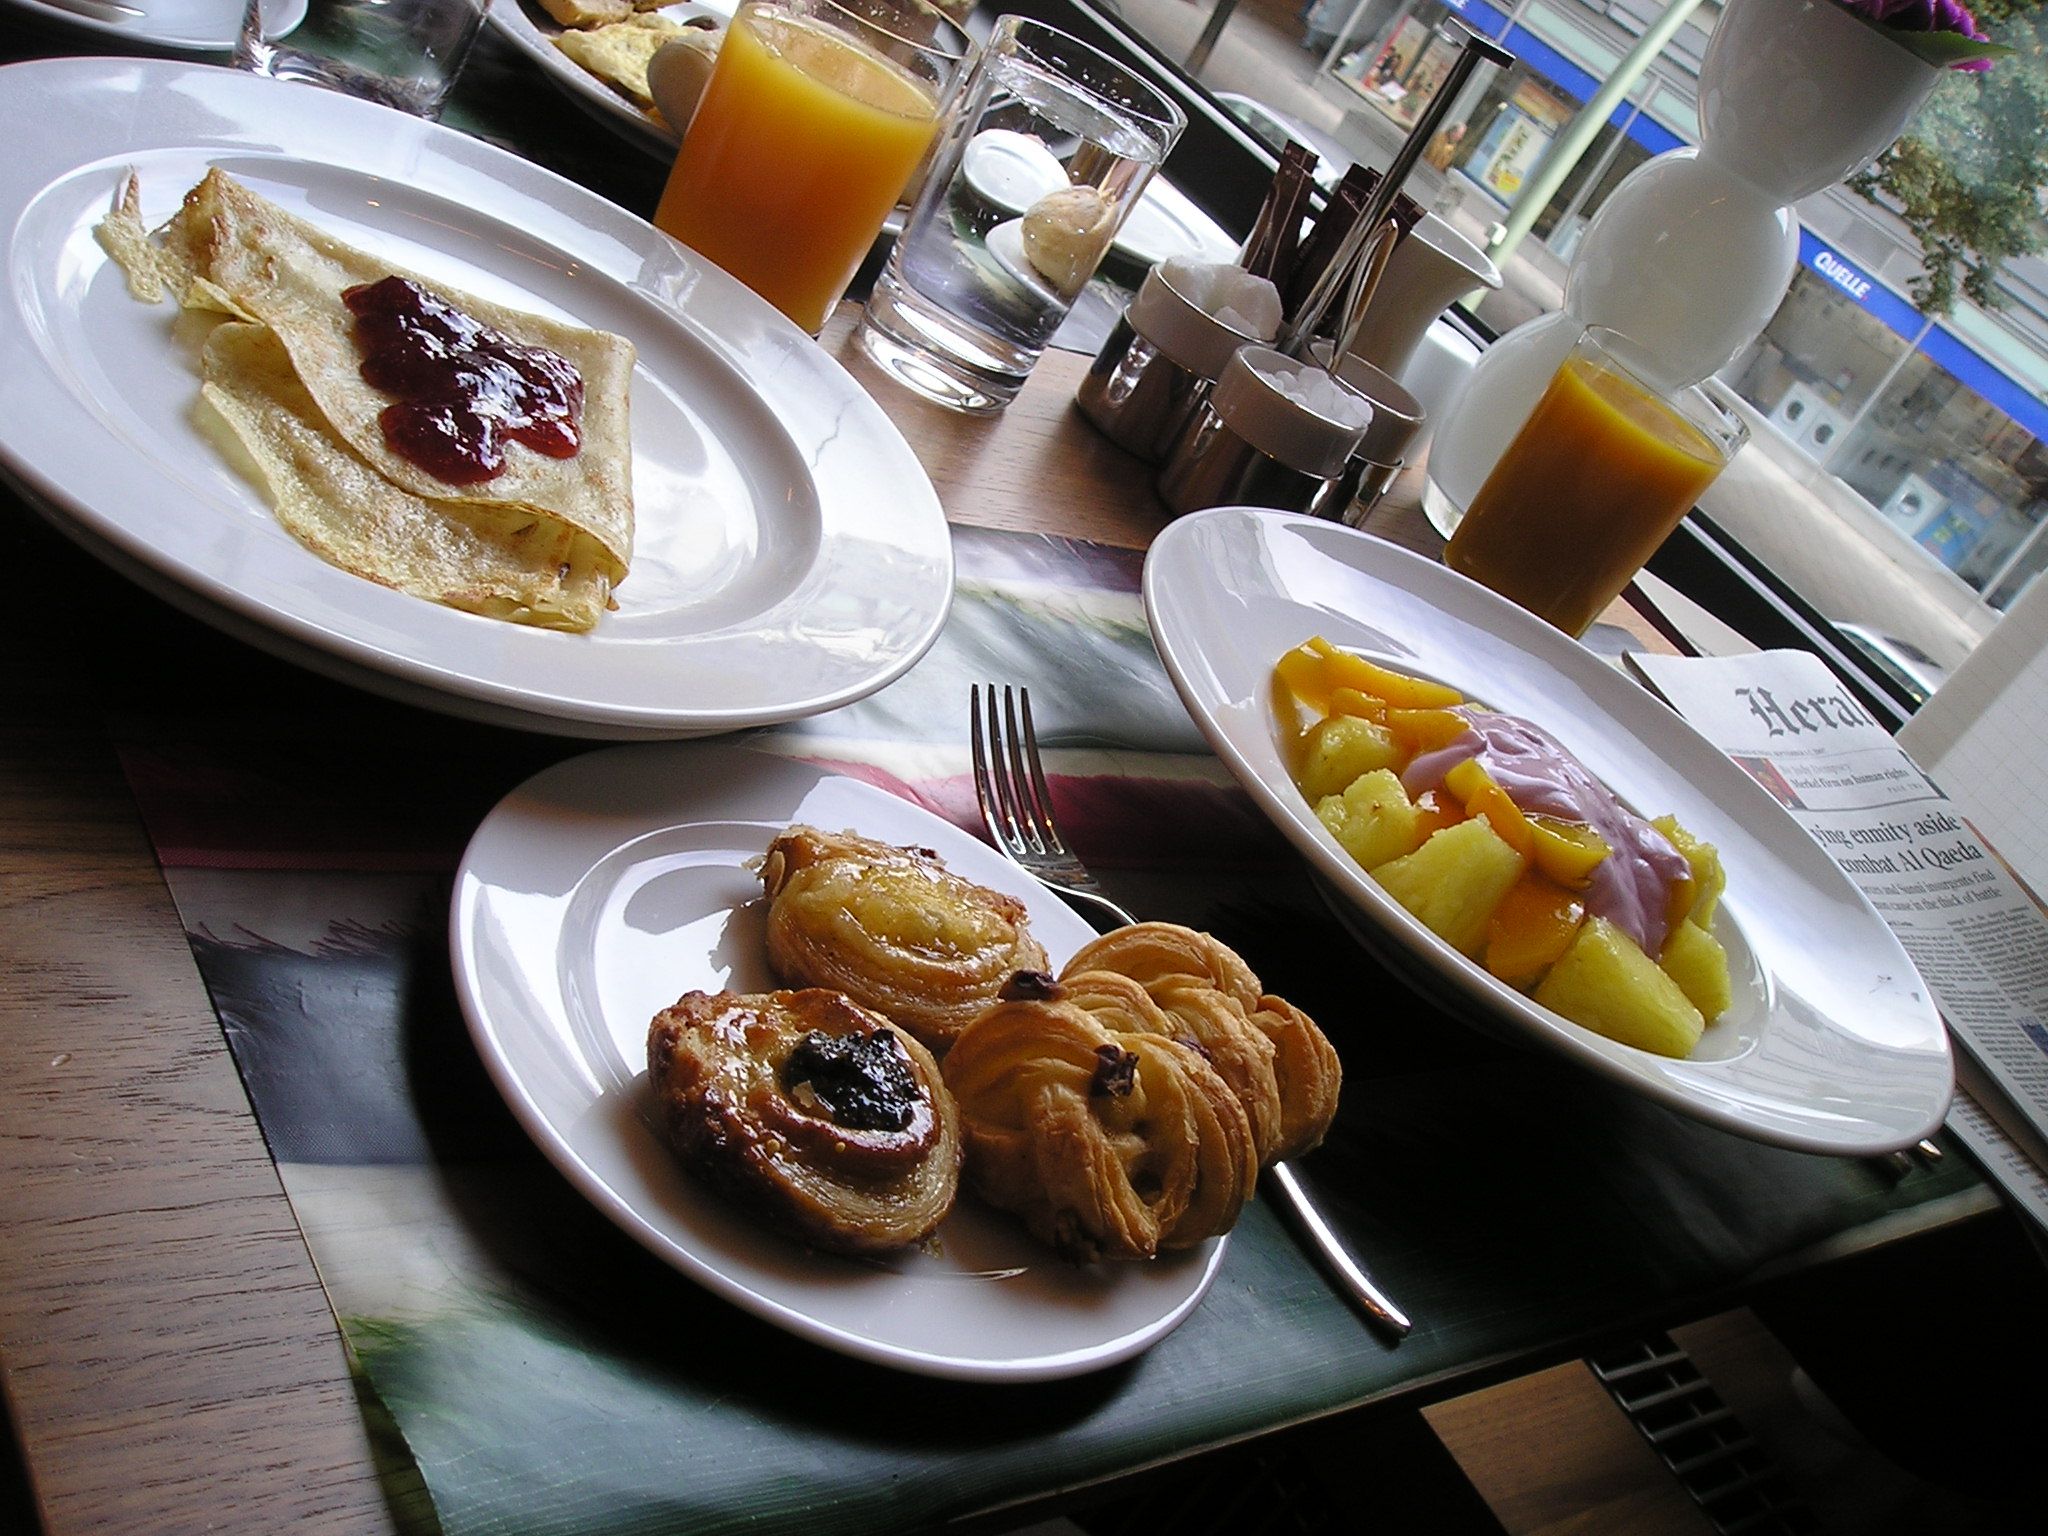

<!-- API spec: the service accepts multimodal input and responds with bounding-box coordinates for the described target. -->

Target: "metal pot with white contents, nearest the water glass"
[1075,262,1278,463]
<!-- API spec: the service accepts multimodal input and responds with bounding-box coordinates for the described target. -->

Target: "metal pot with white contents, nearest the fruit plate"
[1157,346,1372,518]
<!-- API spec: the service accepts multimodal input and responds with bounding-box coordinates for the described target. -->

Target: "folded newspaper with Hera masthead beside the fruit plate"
[1628,651,2048,1227]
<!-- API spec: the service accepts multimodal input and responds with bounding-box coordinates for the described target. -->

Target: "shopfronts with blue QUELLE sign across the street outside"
[1319,0,2048,608]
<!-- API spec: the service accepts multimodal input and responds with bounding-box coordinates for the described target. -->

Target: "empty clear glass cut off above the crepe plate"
[236,0,489,117]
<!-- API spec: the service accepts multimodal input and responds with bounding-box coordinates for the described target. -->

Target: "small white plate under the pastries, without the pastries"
[449,741,1225,1380]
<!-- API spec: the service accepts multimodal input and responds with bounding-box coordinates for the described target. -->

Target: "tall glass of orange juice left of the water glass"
[653,0,973,336]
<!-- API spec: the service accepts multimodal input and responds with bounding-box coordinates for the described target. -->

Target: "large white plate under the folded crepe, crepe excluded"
[0,59,952,739]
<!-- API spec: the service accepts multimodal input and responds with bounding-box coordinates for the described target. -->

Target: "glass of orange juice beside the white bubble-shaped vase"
[1444,326,1749,637]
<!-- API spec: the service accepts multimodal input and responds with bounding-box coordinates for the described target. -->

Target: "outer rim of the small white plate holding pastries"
[446,739,1231,1384]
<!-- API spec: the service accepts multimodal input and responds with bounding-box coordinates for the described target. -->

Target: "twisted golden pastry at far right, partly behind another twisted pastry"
[1061,924,1343,1167]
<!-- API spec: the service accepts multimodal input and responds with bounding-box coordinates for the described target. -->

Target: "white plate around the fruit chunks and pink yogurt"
[1145,508,1954,1155]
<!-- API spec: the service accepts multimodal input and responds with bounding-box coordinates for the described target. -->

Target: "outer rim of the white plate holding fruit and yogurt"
[1143,506,1954,1155]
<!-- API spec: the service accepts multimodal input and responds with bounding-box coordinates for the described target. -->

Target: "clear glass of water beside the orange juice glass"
[860,16,1188,414]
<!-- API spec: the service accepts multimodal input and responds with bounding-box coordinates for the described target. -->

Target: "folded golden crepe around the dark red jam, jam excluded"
[98,170,633,629]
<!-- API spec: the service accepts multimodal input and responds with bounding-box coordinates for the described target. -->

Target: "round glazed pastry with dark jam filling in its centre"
[647,989,963,1253]
